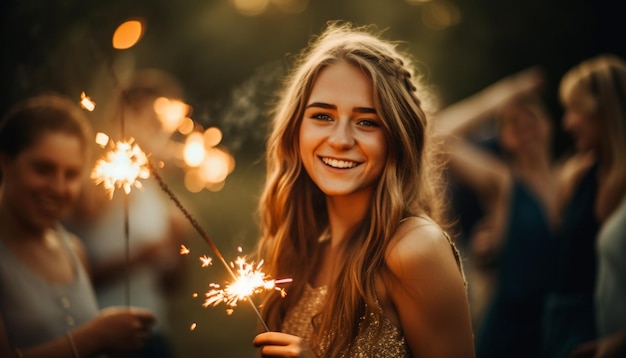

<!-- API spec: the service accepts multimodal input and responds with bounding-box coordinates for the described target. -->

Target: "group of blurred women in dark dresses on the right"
[435,54,626,358]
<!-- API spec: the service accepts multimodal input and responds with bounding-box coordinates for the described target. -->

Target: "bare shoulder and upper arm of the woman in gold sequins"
[385,218,474,358]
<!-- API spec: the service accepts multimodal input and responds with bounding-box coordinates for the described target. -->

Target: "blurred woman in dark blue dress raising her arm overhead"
[435,68,557,358]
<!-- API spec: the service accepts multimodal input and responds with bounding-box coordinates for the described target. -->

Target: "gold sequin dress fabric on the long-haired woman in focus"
[282,285,411,358]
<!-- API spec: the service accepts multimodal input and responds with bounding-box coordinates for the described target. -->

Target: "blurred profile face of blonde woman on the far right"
[563,94,600,151]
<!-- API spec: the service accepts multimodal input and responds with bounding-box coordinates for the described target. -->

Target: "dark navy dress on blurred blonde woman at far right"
[543,164,600,358]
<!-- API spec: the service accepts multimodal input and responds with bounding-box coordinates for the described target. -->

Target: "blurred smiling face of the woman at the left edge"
[1,132,85,230]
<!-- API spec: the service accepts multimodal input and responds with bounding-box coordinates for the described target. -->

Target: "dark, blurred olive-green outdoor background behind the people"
[0,0,626,357]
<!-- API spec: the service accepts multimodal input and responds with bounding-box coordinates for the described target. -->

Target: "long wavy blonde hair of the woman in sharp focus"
[259,22,443,356]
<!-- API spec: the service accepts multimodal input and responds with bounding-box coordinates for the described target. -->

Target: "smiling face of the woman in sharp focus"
[300,61,387,196]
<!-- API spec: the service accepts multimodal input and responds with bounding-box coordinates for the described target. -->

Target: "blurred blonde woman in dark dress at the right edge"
[545,54,626,358]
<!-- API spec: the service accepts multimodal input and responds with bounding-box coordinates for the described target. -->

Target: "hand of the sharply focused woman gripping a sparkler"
[252,332,315,358]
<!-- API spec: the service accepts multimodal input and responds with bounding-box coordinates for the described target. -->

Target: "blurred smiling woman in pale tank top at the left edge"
[0,94,154,358]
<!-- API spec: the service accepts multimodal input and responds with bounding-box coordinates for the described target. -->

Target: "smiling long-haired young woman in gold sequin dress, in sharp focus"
[254,23,474,357]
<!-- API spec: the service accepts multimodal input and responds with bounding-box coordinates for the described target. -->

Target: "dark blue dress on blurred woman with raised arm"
[476,180,552,358]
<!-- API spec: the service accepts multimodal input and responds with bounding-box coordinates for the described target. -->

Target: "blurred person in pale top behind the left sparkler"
[66,70,188,358]
